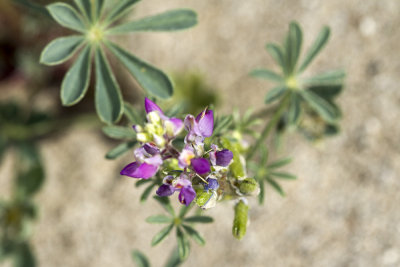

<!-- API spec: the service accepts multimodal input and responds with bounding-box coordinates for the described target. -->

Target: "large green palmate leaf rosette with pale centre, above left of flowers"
[40,0,197,124]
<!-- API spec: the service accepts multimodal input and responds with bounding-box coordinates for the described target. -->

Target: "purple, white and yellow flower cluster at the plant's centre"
[121,98,233,209]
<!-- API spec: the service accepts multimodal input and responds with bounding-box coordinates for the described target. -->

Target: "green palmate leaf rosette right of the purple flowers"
[250,22,345,137]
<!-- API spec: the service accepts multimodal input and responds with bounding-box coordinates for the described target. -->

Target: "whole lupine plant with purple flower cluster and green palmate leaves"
[0,0,345,266]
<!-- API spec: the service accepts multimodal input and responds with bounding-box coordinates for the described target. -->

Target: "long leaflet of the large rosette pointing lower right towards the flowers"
[106,42,173,98]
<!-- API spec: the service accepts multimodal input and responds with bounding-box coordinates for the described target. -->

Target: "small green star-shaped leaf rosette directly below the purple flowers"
[146,196,213,261]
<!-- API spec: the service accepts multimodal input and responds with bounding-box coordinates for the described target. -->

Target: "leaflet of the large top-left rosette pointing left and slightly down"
[40,36,84,65]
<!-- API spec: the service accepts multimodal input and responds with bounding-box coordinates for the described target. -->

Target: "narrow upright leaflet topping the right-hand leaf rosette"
[285,22,303,74]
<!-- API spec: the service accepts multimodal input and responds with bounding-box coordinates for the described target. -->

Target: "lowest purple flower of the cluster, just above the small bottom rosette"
[156,174,196,206]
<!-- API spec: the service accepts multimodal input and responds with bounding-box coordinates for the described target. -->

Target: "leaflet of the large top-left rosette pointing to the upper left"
[46,3,86,33]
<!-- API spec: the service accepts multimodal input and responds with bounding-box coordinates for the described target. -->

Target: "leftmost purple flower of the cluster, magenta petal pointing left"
[120,143,163,179]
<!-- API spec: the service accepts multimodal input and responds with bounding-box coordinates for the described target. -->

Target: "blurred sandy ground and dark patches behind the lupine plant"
[0,0,400,267]
